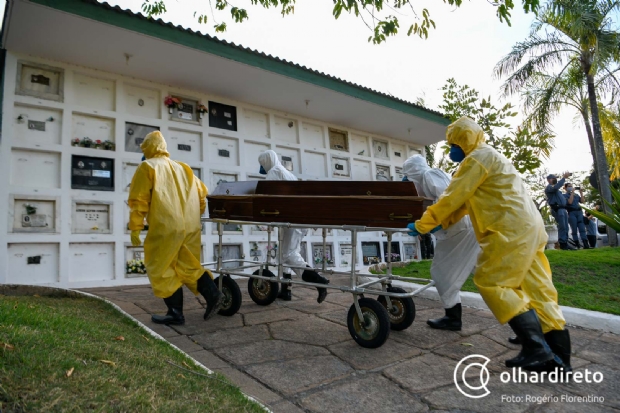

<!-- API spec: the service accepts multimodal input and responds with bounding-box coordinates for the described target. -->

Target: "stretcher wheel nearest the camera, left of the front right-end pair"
[347,298,390,348]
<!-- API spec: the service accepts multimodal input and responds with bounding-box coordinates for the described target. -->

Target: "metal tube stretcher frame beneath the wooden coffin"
[201,218,435,348]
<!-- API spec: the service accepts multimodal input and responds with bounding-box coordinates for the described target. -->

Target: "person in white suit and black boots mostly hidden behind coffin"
[258,150,329,304]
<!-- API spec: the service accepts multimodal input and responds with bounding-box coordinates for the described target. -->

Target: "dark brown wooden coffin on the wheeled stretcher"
[207,181,432,228]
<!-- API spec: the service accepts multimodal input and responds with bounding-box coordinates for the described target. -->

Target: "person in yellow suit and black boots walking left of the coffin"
[129,131,223,325]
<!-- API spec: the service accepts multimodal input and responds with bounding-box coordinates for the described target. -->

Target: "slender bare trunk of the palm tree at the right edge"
[586,72,618,247]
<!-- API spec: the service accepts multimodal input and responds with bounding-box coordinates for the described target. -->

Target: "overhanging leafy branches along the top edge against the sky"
[142,0,540,44]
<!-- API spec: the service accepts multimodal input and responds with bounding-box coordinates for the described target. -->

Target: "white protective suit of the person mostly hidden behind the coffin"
[258,150,308,276]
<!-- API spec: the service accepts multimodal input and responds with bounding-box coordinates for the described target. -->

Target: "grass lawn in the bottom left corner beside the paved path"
[0,296,263,413]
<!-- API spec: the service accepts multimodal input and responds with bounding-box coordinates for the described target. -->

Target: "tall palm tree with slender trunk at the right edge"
[495,0,620,246]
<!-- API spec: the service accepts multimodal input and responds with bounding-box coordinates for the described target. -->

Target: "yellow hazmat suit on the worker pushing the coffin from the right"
[415,117,565,333]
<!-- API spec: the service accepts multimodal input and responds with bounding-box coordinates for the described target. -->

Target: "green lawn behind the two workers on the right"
[378,247,620,315]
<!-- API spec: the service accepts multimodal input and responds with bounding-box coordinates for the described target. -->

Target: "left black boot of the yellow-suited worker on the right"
[506,310,554,370]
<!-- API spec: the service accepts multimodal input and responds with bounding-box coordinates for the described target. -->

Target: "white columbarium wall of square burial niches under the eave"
[0,52,421,288]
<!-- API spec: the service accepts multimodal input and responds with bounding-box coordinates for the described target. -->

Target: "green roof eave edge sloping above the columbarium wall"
[30,0,450,125]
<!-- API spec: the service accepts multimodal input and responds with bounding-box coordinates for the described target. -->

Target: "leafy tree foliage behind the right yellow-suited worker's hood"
[439,79,554,173]
